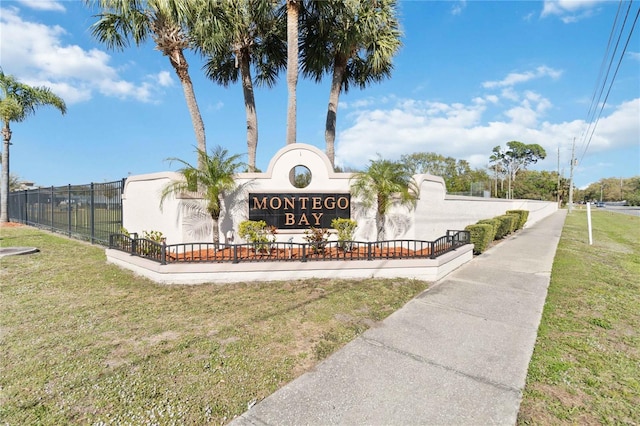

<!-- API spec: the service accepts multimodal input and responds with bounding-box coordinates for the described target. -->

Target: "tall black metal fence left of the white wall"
[8,179,125,245]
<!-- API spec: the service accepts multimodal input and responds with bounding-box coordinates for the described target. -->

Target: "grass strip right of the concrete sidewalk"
[518,210,640,425]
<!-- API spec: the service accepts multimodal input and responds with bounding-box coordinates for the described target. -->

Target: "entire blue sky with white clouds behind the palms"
[0,0,640,187]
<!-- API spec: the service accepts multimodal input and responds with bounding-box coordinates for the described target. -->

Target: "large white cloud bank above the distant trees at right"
[336,91,640,176]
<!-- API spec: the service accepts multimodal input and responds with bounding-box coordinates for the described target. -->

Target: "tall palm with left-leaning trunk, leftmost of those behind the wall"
[85,0,207,169]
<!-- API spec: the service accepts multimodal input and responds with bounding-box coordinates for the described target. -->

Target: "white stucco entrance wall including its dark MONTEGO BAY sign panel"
[122,143,557,244]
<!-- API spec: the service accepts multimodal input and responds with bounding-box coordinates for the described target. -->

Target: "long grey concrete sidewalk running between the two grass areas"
[231,210,566,426]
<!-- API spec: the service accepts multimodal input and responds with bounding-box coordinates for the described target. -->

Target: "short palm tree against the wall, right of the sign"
[351,158,419,241]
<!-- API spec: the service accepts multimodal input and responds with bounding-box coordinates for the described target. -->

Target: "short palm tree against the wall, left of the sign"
[160,146,243,243]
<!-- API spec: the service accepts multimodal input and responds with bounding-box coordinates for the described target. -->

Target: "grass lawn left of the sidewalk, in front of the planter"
[0,227,427,425]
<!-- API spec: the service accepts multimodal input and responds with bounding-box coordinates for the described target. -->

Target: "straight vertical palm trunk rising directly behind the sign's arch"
[287,0,300,145]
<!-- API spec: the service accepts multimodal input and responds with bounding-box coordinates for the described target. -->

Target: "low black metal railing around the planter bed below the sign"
[109,231,471,265]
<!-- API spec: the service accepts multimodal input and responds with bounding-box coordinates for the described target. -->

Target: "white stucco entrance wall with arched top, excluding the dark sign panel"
[123,144,557,244]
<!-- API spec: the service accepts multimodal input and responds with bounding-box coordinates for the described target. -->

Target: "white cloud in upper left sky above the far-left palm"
[0,7,165,104]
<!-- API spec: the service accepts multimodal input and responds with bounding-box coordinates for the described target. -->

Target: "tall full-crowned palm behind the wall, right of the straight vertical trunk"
[301,0,402,165]
